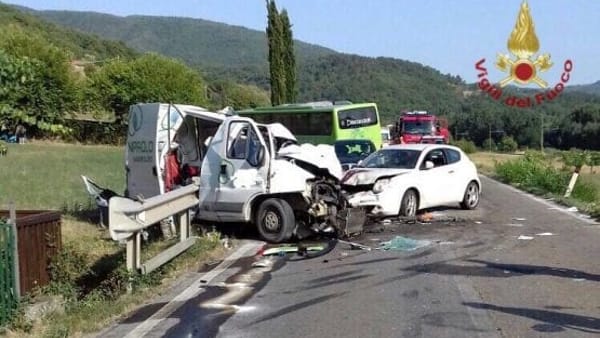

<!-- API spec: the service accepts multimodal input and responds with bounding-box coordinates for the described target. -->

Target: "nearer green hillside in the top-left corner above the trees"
[0,3,137,59]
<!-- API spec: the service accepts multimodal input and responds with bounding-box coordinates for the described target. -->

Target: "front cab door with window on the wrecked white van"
[214,118,270,222]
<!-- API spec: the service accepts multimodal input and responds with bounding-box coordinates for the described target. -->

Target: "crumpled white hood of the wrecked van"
[277,143,342,180]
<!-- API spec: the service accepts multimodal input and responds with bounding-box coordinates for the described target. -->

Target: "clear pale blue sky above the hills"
[5,0,600,86]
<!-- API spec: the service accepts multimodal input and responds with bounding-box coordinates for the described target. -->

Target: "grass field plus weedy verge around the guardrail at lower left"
[0,142,224,337]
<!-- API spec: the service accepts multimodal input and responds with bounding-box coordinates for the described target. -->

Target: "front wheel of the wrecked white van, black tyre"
[256,198,296,243]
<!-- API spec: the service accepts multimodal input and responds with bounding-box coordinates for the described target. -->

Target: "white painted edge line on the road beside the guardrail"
[125,242,263,338]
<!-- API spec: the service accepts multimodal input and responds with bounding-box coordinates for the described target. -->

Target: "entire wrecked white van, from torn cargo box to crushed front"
[116,103,366,242]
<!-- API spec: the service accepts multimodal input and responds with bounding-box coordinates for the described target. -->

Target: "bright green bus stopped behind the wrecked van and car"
[236,101,381,149]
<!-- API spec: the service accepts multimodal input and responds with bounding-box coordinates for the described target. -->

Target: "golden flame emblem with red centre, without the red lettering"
[496,0,552,88]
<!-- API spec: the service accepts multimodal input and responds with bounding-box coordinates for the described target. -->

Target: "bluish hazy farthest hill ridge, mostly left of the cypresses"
[32,11,334,68]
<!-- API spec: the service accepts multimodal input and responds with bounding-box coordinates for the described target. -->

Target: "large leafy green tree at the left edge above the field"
[0,29,76,134]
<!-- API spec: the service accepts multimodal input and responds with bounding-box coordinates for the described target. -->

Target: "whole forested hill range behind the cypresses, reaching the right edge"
[7,1,600,147]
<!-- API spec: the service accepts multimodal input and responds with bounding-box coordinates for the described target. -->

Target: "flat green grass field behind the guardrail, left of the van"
[0,143,125,210]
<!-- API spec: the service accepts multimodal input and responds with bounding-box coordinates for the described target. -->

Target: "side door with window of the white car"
[419,148,453,208]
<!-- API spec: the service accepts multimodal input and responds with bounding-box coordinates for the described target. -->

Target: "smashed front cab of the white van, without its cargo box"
[197,116,366,242]
